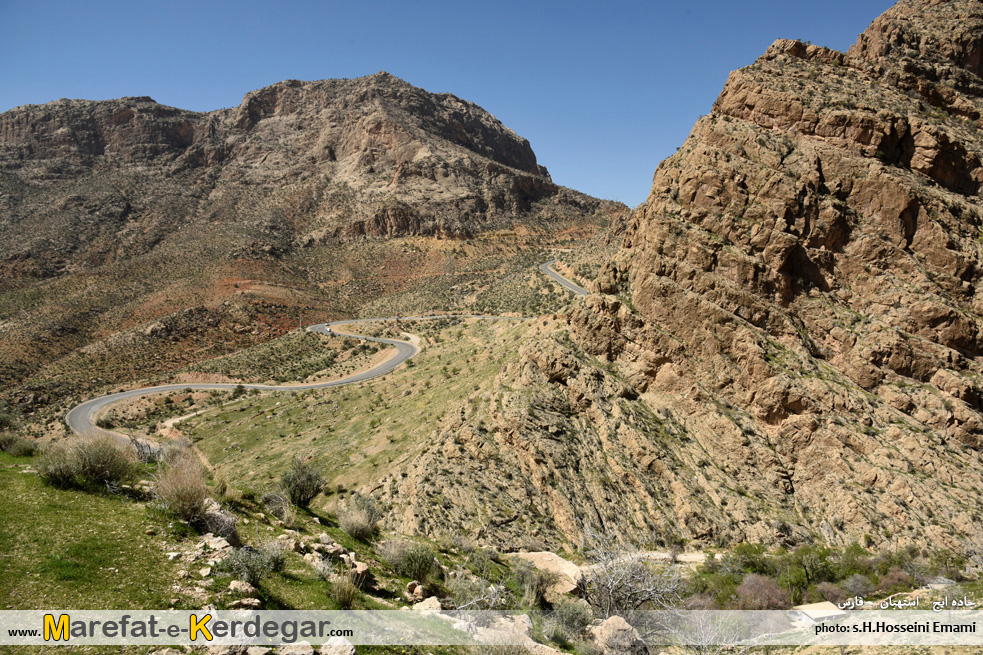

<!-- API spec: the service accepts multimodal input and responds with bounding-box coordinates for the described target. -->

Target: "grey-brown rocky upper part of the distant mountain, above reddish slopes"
[0,73,583,277]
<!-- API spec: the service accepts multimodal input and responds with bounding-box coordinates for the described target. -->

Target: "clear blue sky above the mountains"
[0,0,893,206]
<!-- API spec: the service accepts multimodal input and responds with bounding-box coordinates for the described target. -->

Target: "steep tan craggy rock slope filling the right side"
[382,0,983,551]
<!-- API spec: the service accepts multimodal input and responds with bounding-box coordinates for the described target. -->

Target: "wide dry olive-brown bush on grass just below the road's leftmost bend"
[36,435,136,491]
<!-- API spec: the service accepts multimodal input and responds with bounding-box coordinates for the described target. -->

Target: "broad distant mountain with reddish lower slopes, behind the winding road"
[0,73,621,422]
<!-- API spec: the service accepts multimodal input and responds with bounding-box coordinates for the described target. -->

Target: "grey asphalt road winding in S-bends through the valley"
[65,259,587,447]
